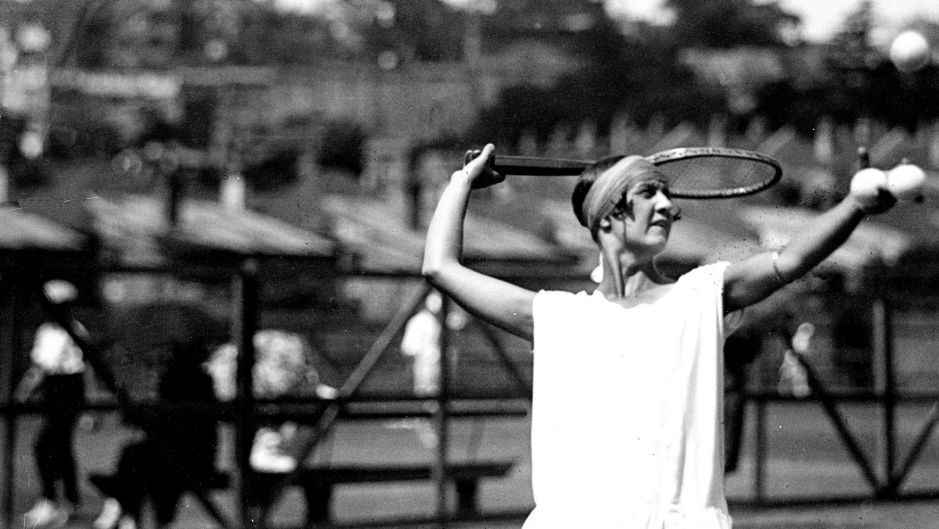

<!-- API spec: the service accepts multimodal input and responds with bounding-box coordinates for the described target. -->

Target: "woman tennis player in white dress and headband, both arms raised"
[423,144,896,529]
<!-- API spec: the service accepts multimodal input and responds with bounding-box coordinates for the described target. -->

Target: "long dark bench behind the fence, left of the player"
[89,461,513,524]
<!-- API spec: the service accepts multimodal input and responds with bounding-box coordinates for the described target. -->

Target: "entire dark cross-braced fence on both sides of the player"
[0,259,939,529]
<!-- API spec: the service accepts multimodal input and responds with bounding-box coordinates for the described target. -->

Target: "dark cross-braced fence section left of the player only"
[0,259,548,529]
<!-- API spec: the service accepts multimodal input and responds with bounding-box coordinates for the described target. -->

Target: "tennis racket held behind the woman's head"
[467,147,782,199]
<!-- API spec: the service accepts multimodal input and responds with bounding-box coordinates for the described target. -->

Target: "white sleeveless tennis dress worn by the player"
[524,263,739,529]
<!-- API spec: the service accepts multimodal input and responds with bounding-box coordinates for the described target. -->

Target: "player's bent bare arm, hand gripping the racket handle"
[421,144,535,340]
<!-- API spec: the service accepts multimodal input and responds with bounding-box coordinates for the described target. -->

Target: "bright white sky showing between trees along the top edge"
[275,0,939,42]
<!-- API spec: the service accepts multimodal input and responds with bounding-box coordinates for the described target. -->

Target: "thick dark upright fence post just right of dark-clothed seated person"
[233,259,263,528]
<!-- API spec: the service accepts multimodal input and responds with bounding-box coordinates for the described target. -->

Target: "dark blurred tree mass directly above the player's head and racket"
[472,10,724,144]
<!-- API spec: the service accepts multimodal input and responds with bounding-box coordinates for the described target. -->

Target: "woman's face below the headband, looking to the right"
[615,180,679,253]
